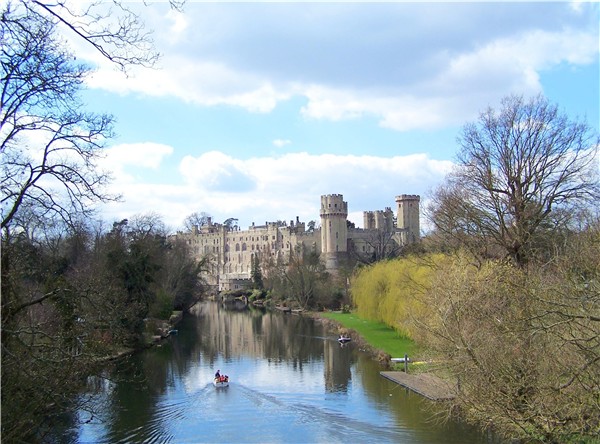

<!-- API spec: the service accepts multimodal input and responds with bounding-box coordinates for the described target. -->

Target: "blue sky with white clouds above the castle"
[71,1,600,231]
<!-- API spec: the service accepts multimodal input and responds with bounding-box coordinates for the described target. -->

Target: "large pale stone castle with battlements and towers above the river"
[175,194,420,291]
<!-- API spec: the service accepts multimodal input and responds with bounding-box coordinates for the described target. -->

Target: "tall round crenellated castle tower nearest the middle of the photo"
[321,194,348,269]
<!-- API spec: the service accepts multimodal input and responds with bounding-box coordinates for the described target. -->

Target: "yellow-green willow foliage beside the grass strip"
[350,254,445,337]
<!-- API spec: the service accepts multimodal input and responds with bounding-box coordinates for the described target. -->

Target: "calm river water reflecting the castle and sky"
[61,302,488,444]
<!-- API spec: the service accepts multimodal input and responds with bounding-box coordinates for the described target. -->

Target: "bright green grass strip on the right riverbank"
[321,312,419,358]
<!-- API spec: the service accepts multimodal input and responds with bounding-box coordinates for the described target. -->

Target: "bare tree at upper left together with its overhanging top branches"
[0,0,188,229]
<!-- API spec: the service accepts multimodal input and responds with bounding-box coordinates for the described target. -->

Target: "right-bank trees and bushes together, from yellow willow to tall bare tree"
[351,97,600,443]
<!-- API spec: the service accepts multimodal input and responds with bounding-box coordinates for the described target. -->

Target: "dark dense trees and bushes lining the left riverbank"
[2,216,202,442]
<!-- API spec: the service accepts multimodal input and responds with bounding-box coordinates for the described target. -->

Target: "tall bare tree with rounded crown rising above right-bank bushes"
[428,96,600,266]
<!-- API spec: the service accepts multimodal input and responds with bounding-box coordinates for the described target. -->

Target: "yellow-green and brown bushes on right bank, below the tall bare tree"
[351,229,600,442]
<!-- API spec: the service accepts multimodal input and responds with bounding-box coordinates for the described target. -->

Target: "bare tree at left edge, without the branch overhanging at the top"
[0,7,117,229]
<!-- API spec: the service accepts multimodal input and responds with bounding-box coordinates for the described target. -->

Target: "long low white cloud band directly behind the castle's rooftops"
[103,151,451,228]
